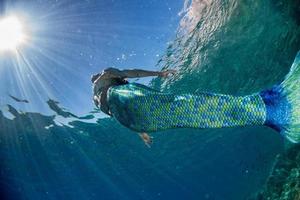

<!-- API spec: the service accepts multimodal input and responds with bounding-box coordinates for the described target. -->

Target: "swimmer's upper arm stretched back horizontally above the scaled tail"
[104,68,176,78]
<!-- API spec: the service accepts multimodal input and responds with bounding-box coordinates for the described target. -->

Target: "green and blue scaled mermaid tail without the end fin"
[108,83,266,132]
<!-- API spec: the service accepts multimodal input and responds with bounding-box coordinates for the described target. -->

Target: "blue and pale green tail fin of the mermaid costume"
[260,52,300,143]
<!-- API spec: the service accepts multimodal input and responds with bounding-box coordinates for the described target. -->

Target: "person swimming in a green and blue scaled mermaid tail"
[92,52,300,146]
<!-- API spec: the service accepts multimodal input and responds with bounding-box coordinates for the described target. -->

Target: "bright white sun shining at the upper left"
[0,16,26,52]
